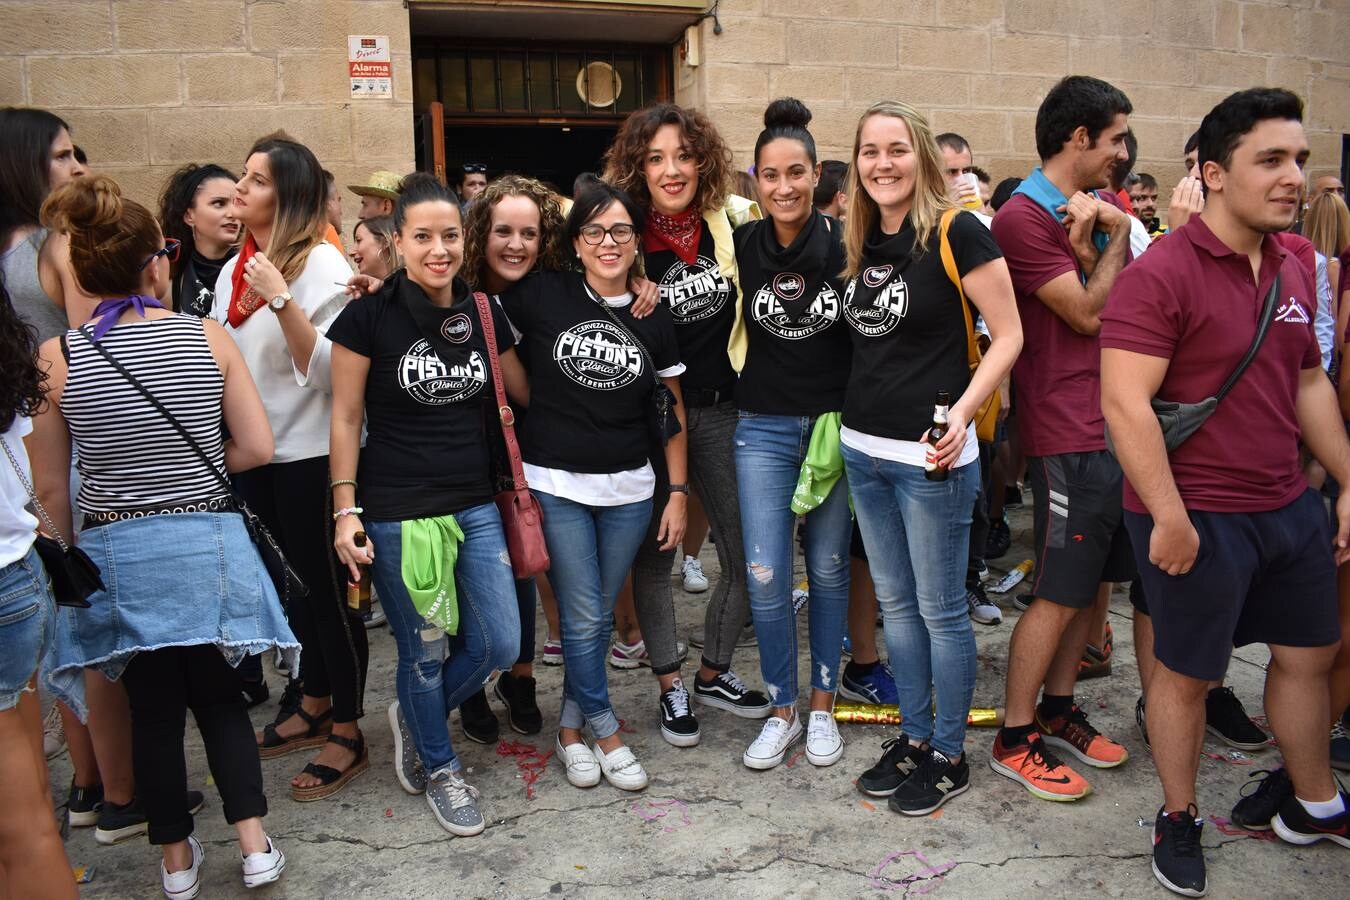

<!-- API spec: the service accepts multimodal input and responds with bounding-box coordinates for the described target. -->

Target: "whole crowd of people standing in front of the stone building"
[0,76,1350,899]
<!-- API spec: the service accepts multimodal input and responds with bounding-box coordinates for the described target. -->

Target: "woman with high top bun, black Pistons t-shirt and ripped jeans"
[736,99,853,769]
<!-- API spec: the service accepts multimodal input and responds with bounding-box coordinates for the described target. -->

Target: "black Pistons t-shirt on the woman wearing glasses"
[501,273,680,474]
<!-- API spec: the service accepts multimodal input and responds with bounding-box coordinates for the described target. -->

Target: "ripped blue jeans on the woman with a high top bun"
[734,412,853,707]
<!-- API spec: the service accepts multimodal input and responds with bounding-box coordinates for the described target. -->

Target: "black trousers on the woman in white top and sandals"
[235,456,370,722]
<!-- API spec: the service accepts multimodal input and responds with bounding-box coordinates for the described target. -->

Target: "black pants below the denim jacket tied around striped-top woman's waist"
[122,644,267,843]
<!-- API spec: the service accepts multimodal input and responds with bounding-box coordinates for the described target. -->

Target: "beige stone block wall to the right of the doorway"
[675,0,1350,194]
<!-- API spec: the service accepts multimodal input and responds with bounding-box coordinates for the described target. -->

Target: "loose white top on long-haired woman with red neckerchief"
[212,242,351,463]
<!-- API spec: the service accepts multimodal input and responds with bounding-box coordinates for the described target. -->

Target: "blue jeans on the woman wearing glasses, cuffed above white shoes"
[535,491,652,738]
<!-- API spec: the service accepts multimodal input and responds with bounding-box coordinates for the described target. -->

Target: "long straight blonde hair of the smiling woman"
[841,100,954,279]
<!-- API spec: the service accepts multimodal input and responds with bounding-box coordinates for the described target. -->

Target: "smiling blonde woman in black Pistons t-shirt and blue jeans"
[840,101,1022,815]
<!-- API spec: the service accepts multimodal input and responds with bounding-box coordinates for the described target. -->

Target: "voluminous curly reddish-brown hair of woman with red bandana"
[605,103,733,213]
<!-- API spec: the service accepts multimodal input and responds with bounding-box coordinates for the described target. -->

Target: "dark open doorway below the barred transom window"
[437,124,617,197]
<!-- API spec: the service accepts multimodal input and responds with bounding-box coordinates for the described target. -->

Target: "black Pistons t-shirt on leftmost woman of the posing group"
[328,273,513,521]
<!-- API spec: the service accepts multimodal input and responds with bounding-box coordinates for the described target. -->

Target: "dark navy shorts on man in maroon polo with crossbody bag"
[1125,488,1341,680]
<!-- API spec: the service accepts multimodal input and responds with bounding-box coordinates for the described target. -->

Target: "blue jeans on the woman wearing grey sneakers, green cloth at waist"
[366,503,520,772]
